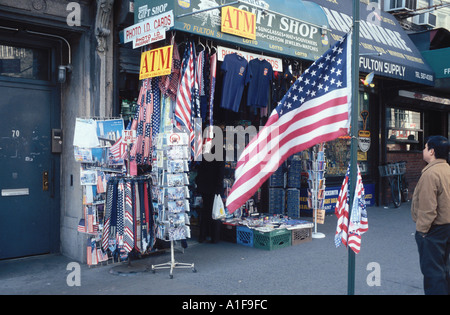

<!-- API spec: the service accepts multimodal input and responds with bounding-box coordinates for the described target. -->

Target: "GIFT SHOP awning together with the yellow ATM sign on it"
[135,0,330,61]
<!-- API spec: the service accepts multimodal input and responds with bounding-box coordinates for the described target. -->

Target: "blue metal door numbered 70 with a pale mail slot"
[0,38,59,259]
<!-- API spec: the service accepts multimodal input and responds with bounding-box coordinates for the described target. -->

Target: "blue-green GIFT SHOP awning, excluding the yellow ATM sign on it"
[134,0,331,60]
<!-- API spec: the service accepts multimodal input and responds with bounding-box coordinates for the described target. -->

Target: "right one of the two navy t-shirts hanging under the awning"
[247,59,273,107]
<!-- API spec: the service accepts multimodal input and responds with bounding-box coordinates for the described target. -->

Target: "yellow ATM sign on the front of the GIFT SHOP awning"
[221,6,256,40]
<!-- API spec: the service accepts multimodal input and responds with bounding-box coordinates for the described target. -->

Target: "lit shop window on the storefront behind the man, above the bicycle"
[386,107,423,151]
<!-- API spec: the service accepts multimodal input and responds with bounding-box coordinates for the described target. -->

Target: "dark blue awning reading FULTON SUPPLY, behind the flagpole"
[314,0,434,86]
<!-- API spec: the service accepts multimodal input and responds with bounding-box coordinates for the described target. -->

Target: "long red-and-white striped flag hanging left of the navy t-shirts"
[175,42,195,160]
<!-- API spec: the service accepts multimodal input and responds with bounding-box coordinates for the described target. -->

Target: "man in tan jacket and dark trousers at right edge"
[411,136,450,295]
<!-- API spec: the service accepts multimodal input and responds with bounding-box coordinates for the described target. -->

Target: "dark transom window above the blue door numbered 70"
[0,43,50,81]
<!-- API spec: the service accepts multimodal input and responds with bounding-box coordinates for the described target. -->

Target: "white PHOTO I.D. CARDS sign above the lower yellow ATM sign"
[121,11,174,48]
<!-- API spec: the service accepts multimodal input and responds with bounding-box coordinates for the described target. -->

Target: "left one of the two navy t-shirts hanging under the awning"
[220,53,249,112]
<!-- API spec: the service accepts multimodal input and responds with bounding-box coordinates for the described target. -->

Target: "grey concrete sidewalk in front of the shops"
[0,203,423,295]
